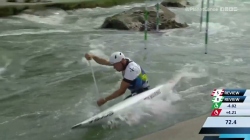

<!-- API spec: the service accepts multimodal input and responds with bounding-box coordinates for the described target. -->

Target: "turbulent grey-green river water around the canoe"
[0,0,250,140]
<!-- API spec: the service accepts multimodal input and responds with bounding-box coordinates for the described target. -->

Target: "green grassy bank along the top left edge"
[0,0,144,17]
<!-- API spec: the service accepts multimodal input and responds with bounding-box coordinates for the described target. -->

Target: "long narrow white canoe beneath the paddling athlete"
[72,85,163,129]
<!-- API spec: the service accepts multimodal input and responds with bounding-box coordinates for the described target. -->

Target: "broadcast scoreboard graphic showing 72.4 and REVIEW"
[199,89,250,140]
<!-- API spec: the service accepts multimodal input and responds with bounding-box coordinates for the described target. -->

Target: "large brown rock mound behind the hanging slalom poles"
[101,4,188,31]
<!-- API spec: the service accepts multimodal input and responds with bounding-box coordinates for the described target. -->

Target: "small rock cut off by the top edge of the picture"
[161,0,190,8]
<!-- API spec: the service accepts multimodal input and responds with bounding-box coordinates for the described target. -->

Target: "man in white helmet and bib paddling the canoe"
[85,52,149,106]
